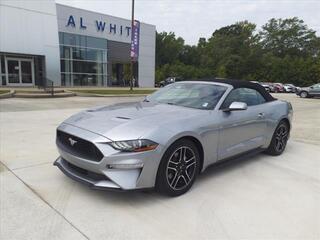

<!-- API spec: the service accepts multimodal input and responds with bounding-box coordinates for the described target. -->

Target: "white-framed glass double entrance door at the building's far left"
[6,58,34,86]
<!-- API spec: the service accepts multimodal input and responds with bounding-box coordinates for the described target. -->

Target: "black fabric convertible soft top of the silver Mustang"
[188,78,276,102]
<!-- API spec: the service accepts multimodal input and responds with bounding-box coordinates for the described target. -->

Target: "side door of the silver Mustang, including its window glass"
[218,88,267,160]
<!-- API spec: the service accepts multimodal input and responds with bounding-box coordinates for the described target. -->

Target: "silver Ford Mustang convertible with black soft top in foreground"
[54,79,293,196]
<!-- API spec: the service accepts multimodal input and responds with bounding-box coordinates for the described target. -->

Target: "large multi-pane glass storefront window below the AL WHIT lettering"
[59,32,107,86]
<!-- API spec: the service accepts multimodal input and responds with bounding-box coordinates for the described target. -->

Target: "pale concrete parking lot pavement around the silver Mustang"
[0,94,320,240]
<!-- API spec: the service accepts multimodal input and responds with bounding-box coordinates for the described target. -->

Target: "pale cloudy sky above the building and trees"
[56,0,320,45]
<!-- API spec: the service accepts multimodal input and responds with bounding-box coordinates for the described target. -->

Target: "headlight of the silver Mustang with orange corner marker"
[108,139,158,152]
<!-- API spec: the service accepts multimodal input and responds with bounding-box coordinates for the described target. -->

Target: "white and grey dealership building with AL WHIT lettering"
[0,0,156,87]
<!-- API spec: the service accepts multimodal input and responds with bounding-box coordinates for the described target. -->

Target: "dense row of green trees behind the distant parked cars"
[156,17,320,86]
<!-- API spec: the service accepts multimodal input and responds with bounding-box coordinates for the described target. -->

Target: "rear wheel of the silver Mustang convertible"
[265,120,290,156]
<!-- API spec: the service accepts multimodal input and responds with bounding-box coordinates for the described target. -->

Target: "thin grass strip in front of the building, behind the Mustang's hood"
[69,89,156,95]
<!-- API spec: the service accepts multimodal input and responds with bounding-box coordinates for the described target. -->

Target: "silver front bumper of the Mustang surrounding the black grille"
[54,124,162,190]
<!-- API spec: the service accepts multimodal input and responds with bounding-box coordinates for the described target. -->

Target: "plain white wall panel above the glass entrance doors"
[0,0,60,85]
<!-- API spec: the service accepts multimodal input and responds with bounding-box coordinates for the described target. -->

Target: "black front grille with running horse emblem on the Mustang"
[57,130,103,162]
